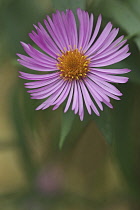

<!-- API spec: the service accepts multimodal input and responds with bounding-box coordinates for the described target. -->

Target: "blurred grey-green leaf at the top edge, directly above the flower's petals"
[52,0,85,12]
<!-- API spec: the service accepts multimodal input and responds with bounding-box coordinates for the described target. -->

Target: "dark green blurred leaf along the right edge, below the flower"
[112,82,140,194]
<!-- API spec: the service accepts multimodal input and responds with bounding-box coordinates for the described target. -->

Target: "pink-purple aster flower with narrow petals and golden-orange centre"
[17,9,130,120]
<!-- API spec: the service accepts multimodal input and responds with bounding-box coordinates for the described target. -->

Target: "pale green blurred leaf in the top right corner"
[100,0,140,48]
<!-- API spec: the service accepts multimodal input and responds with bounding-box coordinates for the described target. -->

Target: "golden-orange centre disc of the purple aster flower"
[57,49,90,80]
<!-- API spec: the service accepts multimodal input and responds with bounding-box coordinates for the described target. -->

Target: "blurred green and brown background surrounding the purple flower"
[0,0,140,210]
